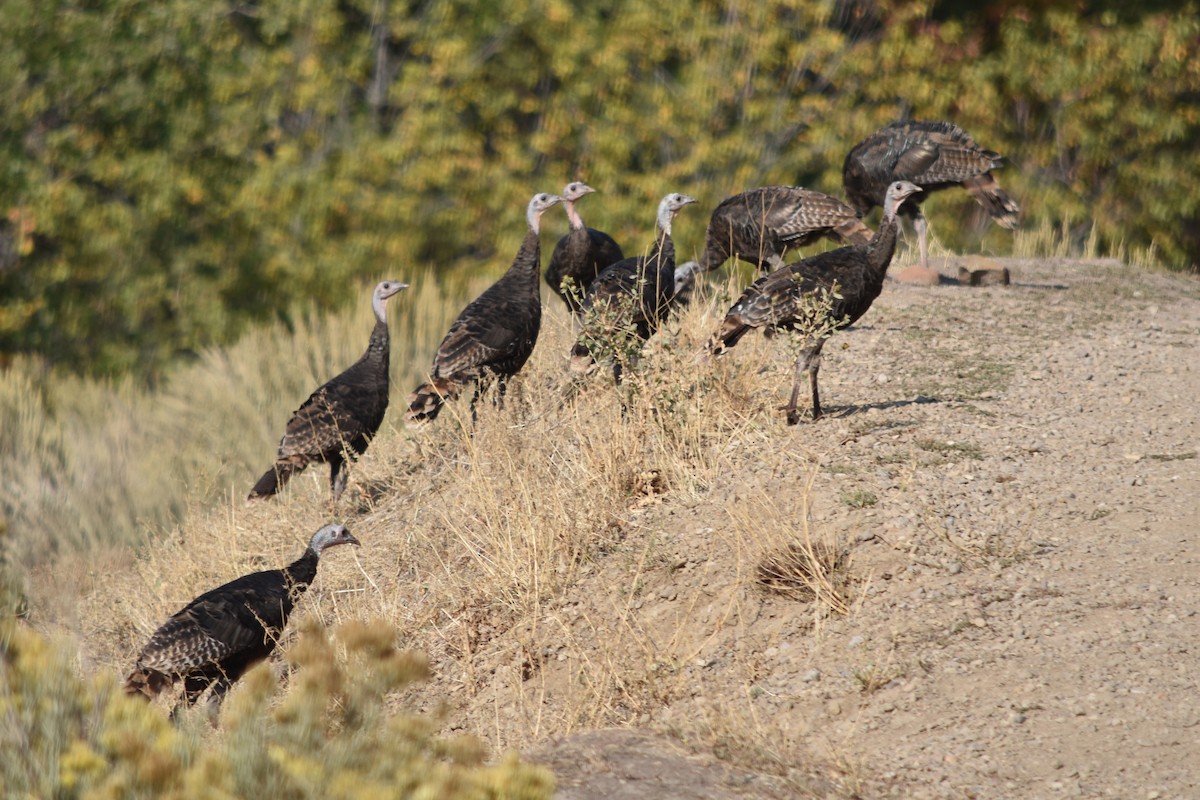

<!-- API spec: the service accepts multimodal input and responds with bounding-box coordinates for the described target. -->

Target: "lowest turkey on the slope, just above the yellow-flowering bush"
[125,524,359,716]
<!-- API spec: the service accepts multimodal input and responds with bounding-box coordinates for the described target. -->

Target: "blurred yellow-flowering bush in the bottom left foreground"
[0,620,553,800]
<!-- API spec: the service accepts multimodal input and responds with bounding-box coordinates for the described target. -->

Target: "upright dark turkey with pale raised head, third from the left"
[408,193,563,422]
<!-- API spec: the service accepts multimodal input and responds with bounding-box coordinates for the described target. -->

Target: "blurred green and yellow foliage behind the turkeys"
[7,0,1200,378]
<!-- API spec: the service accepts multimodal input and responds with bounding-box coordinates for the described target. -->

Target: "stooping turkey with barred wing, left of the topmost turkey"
[700,186,871,272]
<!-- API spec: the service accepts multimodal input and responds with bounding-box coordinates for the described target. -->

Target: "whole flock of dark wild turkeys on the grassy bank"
[125,120,1020,715]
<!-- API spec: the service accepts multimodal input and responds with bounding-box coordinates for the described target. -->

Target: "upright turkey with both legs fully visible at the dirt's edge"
[709,181,920,425]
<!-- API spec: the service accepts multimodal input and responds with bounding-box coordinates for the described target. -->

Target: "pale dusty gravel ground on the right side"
[508,261,1200,799]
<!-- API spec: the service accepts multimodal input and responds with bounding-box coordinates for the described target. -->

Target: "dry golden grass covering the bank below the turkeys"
[46,271,878,786]
